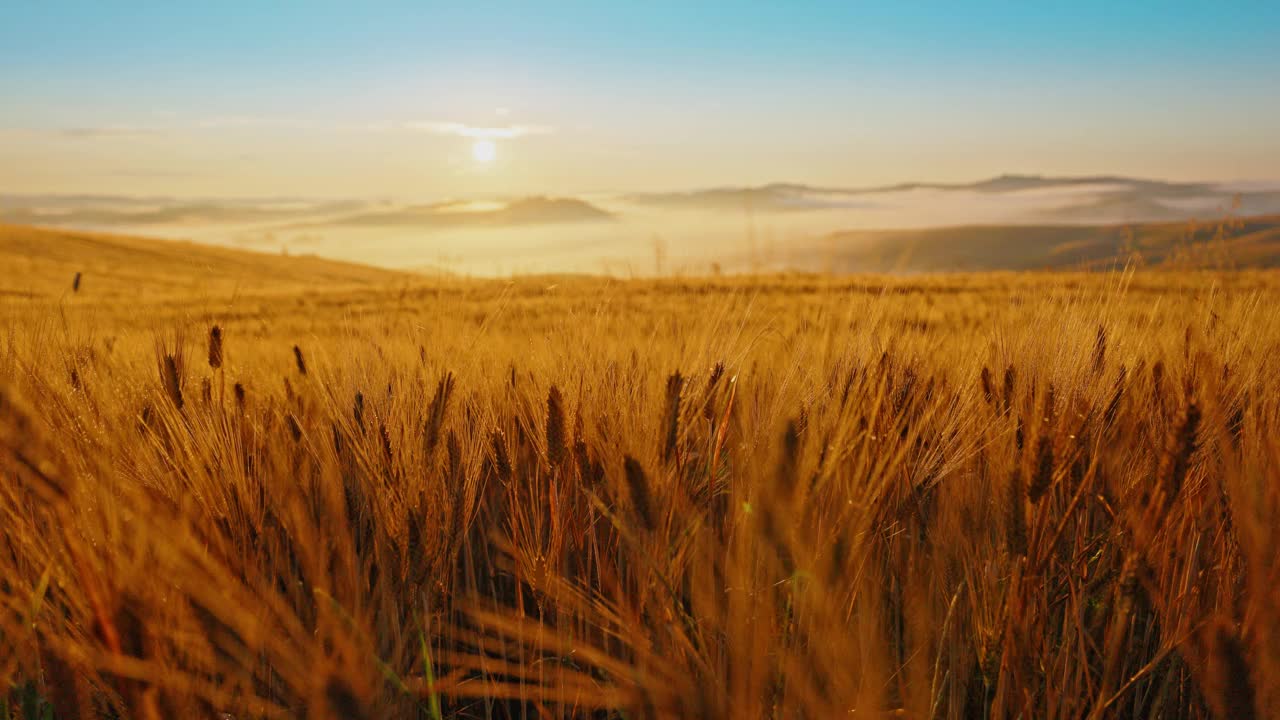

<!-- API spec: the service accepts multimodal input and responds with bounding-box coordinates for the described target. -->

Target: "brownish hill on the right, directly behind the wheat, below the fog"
[790,215,1280,273]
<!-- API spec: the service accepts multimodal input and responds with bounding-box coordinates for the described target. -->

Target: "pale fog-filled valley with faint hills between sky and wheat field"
[0,176,1280,277]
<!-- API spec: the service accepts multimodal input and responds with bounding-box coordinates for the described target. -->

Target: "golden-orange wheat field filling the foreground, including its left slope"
[0,228,1280,720]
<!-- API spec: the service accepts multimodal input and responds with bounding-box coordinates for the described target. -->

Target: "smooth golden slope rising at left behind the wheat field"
[0,225,406,297]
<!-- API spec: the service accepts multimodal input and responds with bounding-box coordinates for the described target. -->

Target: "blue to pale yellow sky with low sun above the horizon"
[0,0,1280,199]
